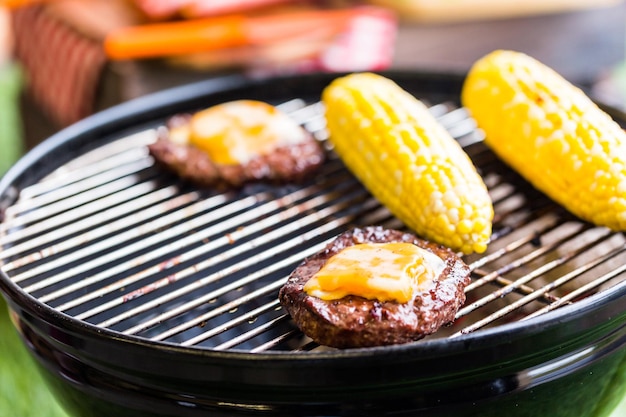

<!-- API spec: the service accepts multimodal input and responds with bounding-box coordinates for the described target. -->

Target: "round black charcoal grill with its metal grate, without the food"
[0,72,626,417]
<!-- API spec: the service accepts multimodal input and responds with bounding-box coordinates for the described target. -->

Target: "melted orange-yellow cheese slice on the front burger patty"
[304,243,445,303]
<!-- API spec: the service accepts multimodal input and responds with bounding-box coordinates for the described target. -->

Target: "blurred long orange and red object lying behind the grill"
[105,6,397,71]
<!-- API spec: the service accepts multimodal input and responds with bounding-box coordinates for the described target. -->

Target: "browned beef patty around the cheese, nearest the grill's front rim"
[279,227,470,348]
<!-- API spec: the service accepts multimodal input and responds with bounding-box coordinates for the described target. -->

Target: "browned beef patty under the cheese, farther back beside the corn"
[148,115,325,188]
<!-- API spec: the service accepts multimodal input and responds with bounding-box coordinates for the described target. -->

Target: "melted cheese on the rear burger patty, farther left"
[189,100,306,165]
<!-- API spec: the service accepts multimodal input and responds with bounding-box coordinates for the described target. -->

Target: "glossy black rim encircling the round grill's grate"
[0,71,626,361]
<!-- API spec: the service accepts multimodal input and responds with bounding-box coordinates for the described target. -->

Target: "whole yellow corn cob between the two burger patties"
[322,73,493,254]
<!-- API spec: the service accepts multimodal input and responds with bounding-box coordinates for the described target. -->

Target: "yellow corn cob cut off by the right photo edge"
[461,50,626,231]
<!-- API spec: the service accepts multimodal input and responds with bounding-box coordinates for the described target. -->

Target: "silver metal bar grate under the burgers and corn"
[0,100,626,352]
